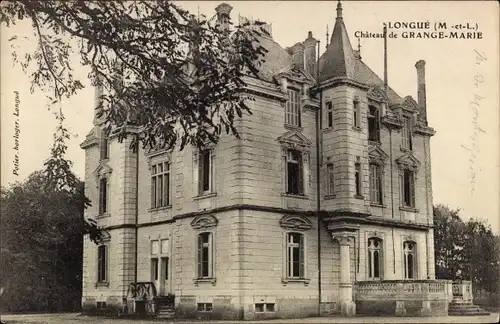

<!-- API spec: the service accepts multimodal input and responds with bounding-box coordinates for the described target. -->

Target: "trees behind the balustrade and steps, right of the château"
[434,205,500,293]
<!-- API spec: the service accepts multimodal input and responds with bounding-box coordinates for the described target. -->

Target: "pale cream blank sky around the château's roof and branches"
[0,1,500,233]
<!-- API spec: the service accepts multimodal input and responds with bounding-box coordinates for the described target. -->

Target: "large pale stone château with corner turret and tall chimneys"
[81,2,466,319]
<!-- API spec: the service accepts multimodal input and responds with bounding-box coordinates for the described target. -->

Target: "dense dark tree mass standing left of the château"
[0,171,86,312]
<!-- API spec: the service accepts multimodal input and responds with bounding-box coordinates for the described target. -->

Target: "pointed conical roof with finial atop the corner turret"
[319,1,356,81]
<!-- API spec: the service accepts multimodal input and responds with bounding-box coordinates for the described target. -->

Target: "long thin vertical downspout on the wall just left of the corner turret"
[316,41,323,316]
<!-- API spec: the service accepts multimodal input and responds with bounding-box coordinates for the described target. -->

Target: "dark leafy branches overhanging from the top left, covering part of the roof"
[0,0,266,152]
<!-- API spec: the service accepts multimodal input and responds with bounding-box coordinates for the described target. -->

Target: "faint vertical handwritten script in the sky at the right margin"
[462,49,486,196]
